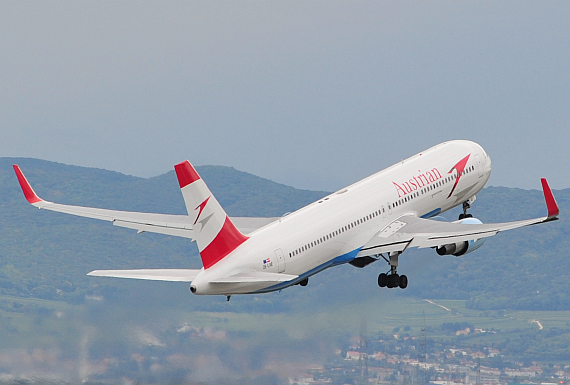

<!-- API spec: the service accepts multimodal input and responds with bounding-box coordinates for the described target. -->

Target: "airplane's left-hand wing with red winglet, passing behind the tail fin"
[14,165,277,239]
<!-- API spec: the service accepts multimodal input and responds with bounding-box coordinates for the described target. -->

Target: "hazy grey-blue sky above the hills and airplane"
[0,1,570,191]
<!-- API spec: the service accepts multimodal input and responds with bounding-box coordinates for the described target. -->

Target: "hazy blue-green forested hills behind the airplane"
[0,158,570,311]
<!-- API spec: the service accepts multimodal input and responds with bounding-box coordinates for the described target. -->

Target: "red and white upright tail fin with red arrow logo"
[174,161,248,269]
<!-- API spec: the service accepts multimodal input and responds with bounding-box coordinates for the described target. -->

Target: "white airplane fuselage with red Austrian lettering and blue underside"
[192,140,491,295]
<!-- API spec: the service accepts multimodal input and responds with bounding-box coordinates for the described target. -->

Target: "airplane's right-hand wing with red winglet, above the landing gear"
[357,178,560,258]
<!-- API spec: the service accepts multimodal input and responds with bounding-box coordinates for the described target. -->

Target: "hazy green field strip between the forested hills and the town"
[0,288,570,346]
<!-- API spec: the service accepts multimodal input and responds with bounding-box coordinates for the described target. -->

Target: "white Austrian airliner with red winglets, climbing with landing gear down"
[14,140,559,301]
